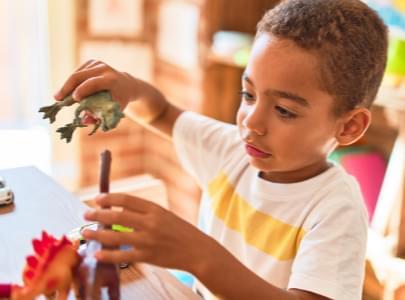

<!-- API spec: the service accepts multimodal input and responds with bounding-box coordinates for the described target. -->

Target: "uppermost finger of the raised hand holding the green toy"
[54,64,105,100]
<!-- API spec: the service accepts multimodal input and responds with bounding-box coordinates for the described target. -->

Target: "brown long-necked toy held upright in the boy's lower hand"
[78,150,120,300]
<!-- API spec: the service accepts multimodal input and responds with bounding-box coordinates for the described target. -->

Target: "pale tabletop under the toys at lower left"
[0,167,200,300]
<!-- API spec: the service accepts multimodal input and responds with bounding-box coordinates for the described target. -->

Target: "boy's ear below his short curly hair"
[336,107,371,146]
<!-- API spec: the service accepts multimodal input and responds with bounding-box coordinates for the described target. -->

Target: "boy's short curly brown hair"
[256,0,388,114]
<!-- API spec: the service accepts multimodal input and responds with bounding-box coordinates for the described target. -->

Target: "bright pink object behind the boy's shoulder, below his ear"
[341,152,386,222]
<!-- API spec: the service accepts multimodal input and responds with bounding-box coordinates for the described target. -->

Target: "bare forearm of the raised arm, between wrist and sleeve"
[125,75,182,137]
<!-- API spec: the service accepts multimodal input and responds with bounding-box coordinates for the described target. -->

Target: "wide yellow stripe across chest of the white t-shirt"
[208,173,305,260]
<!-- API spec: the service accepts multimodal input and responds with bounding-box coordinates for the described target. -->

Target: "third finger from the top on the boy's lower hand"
[82,230,137,247]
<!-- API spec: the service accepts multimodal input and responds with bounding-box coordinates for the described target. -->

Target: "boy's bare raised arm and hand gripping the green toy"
[55,60,182,138]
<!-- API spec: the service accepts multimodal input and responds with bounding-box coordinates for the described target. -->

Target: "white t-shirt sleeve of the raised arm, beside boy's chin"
[173,112,241,185]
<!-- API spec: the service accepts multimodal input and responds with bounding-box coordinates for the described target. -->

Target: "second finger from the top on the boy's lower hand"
[84,209,144,230]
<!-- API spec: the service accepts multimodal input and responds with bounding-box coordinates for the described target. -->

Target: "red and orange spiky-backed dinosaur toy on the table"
[0,231,81,300]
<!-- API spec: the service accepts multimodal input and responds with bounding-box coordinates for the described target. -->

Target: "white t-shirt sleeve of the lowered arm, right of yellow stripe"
[288,193,367,300]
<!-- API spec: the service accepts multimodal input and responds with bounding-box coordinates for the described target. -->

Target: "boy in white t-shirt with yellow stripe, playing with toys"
[55,0,387,300]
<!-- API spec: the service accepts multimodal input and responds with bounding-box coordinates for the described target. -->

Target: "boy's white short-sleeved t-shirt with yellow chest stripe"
[173,112,368,300]
